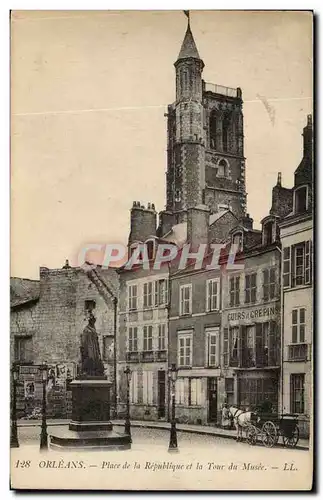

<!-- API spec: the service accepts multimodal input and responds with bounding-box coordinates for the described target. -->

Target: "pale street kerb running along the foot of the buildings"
[18,420,309,451]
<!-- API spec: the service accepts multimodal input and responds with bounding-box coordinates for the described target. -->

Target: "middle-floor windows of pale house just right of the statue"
[128,323,167,352]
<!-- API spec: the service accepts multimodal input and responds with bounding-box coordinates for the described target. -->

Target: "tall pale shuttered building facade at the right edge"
[280,116,313,436]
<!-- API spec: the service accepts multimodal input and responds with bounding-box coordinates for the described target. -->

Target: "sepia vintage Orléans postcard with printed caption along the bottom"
[10,10,315,491]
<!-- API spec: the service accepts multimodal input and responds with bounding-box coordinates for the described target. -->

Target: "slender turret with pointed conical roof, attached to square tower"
[166,23,205,220]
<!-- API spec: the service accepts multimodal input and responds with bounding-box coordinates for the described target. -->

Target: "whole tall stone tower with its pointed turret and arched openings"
[160,17,246,234]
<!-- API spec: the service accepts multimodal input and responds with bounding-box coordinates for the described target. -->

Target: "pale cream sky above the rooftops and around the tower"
[11,11,313,279]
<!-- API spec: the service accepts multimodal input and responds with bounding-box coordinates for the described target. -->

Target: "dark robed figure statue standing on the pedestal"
[80,311,104,377]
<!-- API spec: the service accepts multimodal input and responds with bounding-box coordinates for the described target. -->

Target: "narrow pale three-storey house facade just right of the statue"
[118,267,168,420]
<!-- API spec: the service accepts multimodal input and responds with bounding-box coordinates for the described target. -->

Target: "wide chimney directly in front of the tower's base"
[187,205,210,251]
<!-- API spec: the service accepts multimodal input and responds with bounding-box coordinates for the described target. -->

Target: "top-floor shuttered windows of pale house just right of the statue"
[128,279,168,311]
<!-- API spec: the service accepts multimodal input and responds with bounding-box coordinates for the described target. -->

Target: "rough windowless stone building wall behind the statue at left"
[10,264,118,418]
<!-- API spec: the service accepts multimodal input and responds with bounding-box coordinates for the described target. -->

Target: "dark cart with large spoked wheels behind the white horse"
[247,413,299,448]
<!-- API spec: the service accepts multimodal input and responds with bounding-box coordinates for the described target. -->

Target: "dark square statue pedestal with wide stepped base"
[50,377,131,450]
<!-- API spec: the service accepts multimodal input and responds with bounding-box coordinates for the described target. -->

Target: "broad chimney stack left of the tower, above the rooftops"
[128,201,157,245]
